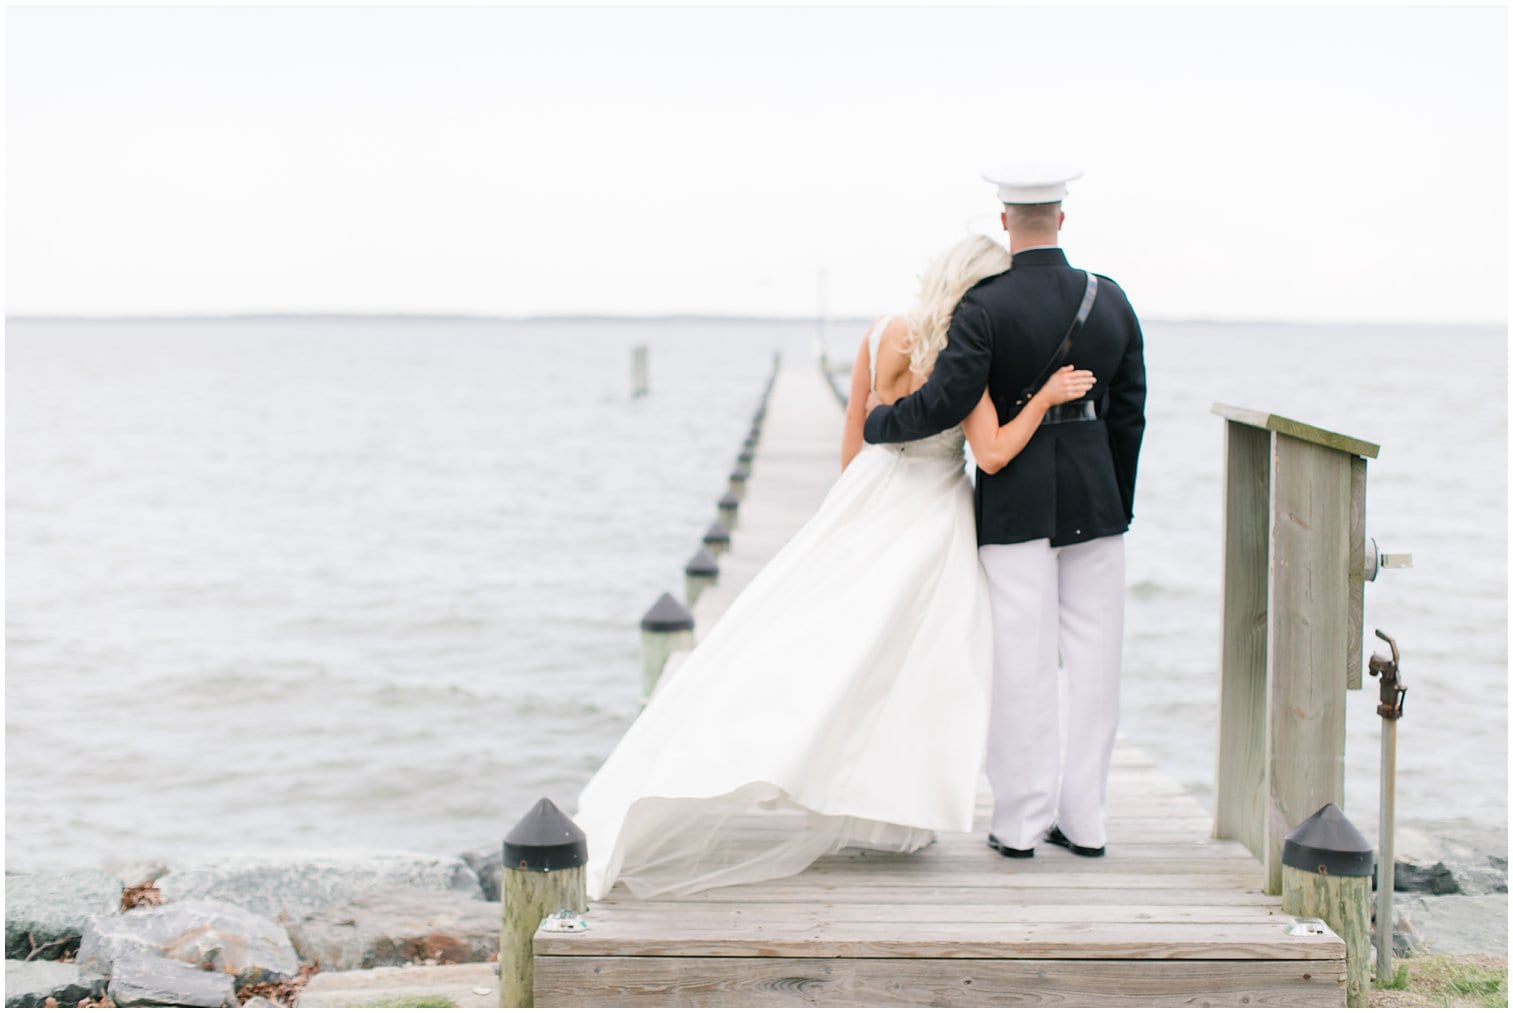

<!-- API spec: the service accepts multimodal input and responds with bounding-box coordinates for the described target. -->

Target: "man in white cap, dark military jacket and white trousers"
[865,168,1145,859]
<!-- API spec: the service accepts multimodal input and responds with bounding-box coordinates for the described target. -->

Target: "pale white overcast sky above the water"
[6,6,1508,322]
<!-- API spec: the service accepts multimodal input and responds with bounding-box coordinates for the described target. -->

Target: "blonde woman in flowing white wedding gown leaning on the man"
[573,236,1092,900]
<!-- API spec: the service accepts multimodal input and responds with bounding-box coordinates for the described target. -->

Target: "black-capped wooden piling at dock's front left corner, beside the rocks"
[499,798,589,1007]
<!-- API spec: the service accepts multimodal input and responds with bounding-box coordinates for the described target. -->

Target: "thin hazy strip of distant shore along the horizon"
[5,310,1508,330]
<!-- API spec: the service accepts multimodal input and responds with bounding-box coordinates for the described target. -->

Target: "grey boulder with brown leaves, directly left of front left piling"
[289,889,499,972]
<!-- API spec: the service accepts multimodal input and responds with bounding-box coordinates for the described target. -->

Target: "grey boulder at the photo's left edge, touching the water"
[5,868,126,960]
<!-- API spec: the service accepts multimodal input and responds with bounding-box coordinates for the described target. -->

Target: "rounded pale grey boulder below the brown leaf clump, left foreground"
[79,901,300,987]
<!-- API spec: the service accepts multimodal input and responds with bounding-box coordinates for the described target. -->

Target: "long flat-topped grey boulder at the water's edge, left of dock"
[157,851,483,921]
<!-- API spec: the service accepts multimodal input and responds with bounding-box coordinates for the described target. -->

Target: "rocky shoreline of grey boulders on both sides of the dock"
[6,829,1507,1007]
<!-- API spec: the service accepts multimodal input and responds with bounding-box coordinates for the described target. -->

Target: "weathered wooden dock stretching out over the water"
[534,367,1345,1007]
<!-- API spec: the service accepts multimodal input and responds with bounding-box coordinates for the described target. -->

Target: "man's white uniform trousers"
[979,535,1124,848]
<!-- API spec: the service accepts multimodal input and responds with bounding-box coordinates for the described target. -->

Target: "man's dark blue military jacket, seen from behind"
[865,248,1145,546]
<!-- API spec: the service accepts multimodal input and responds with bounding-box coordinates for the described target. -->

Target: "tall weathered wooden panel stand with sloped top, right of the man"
[1213,405,1380,894]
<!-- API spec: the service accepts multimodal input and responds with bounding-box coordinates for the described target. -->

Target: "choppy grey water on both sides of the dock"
[6,319,1507,868]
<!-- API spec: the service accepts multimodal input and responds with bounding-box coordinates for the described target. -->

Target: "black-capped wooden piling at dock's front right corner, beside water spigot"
[1282,803,1374,1007]
